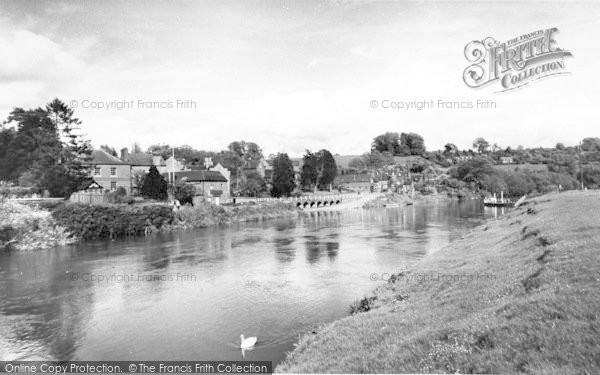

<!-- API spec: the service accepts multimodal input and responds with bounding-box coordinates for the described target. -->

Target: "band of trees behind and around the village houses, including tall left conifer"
[0,99,600,198]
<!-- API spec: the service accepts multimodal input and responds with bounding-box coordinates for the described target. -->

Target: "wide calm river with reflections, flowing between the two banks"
[0,200,506,364]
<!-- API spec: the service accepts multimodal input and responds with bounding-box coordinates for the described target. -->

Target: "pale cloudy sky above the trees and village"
[0,0,600,156]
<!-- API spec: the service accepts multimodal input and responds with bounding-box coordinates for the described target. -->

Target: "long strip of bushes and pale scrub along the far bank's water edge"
[0,201,298,250]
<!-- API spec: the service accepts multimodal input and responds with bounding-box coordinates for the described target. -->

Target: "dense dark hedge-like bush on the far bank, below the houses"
[52,204,174,239]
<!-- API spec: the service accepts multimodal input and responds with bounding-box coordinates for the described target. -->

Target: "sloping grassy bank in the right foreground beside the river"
[277,192,600,374]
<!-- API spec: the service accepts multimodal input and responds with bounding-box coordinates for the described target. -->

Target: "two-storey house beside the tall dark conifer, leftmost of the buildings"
[86,150,131,193]
